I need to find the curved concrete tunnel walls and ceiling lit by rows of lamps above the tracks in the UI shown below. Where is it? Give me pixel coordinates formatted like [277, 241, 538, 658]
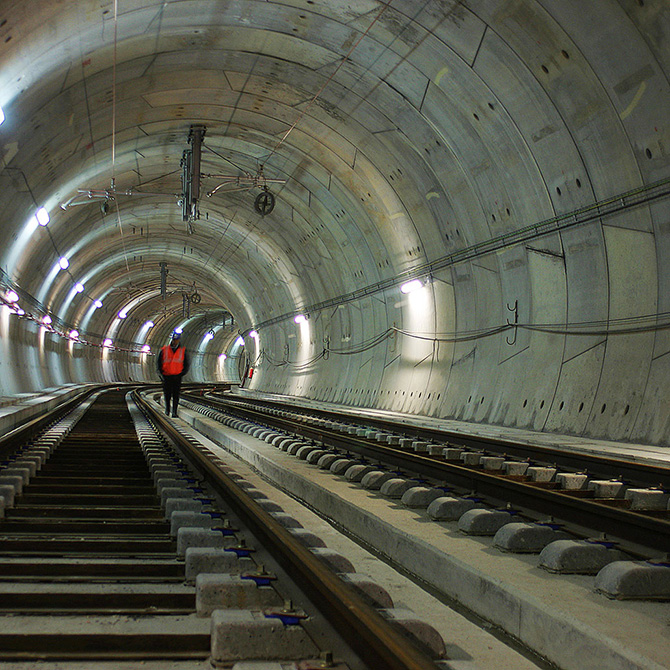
[0, 0, 670, 444]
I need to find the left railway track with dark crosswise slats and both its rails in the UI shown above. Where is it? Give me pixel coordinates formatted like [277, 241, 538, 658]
[0, 391, 452, 670]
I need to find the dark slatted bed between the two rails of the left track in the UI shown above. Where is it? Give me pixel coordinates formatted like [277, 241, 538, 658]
[0, 393, 209, 660]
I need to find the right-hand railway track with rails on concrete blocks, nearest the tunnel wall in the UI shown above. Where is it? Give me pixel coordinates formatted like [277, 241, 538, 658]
[182, 394, 670, 560]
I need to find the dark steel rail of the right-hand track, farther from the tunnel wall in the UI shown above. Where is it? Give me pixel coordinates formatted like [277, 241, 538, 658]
[188, 399, 670, 552]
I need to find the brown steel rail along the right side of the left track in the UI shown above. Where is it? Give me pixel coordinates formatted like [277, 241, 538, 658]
[134, 393, 444, 670]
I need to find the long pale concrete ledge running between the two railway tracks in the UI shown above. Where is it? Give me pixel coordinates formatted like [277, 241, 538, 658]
[181, 417, 670, 670]
